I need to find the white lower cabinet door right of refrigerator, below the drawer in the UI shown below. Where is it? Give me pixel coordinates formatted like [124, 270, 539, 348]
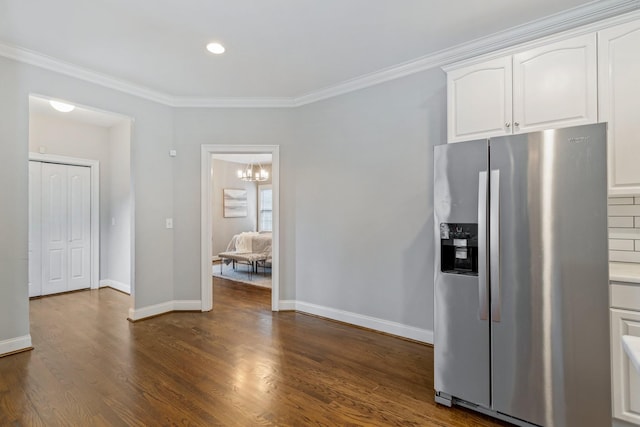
[611, 308, 640, 424]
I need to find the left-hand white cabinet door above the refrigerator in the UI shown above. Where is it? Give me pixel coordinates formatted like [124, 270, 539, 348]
[447, 57, 512, 142]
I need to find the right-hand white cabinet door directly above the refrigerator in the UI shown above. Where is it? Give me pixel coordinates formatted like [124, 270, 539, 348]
[513, 34, 598, 133]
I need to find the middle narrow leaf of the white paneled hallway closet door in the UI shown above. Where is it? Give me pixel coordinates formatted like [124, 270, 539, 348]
[42, 163, 69, 295]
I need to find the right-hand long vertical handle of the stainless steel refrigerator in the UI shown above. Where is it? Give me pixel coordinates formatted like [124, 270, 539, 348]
[489, 169, 502, 322]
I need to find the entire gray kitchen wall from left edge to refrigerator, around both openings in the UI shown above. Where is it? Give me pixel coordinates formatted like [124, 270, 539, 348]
[0, 53, 446, 348]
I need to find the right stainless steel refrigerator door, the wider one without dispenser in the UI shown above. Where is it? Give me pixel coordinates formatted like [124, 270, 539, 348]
[489, 124, 611, 426]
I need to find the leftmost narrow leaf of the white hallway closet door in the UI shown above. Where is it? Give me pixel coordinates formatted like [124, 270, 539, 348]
[29, 162, 42, 297]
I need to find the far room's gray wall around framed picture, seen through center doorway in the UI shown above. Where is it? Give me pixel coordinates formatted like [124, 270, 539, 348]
[211, 159, 258, 255]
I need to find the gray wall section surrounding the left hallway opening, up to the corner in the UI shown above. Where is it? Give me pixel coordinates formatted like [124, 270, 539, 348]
[0, 53, 174, 338]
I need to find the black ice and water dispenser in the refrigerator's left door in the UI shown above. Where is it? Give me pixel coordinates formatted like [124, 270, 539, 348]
[440, 223, 478, 276]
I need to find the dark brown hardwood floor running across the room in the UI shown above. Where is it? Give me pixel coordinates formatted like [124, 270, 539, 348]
[0, 279, 507, 426]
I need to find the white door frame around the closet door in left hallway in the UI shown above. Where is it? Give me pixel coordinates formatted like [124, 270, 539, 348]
[29, 152, 100, 289]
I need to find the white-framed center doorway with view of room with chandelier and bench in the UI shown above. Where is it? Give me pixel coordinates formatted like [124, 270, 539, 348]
[202, 145, 279, 311]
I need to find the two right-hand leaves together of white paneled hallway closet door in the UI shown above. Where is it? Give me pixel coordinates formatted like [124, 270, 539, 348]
[41, 163, 91, 295]
